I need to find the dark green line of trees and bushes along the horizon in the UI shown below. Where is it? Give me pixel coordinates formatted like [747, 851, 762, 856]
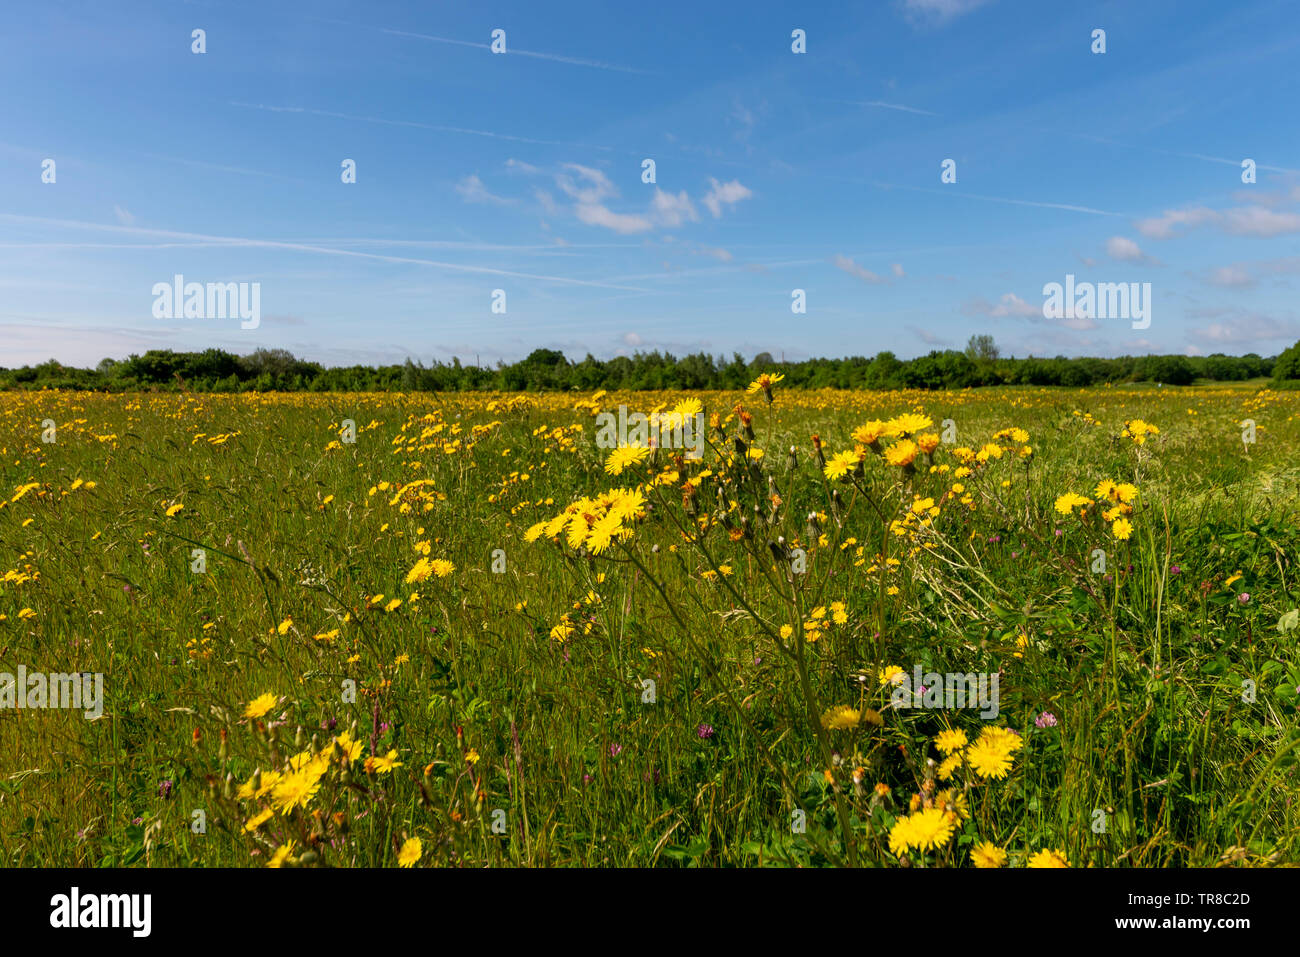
[0, 335, 1300, 393]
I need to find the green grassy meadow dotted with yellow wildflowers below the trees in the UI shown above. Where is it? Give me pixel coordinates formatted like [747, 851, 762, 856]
[0, 376, 1300, 867]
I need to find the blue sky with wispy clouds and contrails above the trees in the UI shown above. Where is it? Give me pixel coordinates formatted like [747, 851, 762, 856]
[0, 0, 1300, 367]
